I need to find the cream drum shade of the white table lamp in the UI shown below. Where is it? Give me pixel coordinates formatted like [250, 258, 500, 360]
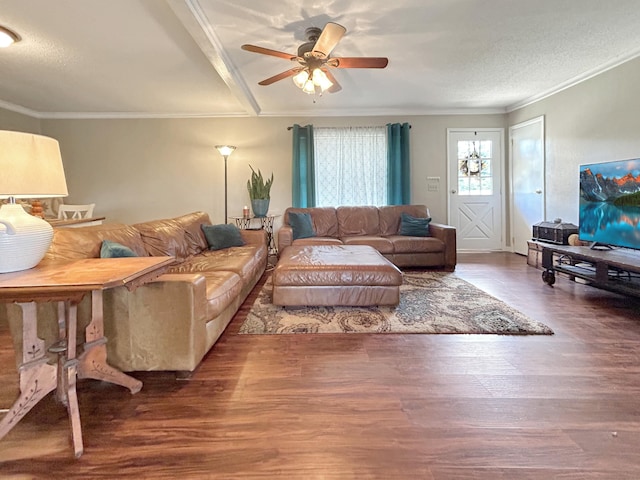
[0, 130, 68, 198]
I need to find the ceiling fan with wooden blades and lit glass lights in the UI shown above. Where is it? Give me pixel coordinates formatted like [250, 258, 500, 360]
[242, 22, 389, 94]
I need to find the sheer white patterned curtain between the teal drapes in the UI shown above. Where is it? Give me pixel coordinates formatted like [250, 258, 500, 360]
[314, 127, 387, 207]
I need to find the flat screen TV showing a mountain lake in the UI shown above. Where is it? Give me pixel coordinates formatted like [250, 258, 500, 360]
[579, 158, 640, 249]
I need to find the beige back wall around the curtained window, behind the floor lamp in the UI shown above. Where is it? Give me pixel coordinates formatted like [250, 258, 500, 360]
[42, 115, 505, 226]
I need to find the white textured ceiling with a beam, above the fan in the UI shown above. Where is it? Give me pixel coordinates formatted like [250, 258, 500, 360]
[0, 0, 640, 118]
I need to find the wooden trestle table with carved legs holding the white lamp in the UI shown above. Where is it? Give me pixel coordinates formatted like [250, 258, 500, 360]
[0, 257, 173, 457]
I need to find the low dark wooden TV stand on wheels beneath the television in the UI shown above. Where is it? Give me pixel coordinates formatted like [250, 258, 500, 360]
[542, 244, 640, 295]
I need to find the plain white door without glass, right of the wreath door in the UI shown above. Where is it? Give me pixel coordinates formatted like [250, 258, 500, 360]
[509, 117, 545, 255]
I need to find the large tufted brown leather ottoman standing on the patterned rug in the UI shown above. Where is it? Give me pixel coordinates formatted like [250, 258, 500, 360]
[272, 245, 402, 306]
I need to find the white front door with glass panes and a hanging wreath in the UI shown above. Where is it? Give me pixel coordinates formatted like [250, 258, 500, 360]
[447, 129, 504, 251]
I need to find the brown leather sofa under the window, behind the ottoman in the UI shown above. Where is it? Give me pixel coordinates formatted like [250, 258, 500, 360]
[278, 205, 456, 271]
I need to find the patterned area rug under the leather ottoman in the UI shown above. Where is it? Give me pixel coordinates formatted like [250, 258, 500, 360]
[239, 272, 553, 335]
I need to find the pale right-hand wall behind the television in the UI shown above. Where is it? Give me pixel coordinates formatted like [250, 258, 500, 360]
[508, 55, 640, 225]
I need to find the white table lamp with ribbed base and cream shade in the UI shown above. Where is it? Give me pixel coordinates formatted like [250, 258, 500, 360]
[0, 131, 68, 273]
